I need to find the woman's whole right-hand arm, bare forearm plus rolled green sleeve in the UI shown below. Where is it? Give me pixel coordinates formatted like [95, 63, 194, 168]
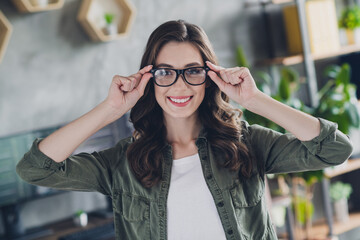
[207, 62, 352, 173]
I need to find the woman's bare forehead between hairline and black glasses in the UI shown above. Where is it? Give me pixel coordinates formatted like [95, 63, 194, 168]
[156, 41, 204, 67]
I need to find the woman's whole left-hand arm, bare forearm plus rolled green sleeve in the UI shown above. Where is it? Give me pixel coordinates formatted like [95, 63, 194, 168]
[16, 66, 151, 194]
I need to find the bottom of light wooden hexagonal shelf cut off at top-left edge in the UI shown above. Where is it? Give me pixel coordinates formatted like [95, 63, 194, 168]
[12, 0, 64, 13]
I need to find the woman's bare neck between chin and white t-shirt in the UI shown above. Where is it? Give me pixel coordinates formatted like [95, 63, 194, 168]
[164, 114, 201, 144]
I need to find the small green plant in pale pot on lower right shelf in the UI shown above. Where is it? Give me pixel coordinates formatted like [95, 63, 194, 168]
[330, 181, 352, 222]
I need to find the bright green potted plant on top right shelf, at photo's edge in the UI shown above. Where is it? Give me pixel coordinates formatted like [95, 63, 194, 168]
[338, 5, 360, 45]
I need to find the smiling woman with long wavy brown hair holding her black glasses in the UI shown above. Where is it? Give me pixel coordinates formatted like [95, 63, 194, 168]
[17, 21, 352, 239]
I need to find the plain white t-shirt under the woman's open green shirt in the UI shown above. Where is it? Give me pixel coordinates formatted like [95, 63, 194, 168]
[167, 154, 226, 240]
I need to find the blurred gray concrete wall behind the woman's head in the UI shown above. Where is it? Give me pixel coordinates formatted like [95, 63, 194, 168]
[0, 0, 270, 136]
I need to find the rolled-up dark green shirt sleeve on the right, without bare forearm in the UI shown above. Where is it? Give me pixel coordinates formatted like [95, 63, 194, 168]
[245, 118, 353, 173]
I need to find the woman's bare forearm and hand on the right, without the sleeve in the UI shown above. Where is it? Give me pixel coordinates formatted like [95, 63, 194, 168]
[207, 62, 320, 141]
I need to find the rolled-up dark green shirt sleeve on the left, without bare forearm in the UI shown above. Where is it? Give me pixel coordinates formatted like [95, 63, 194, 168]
[16, 139, 115, 195]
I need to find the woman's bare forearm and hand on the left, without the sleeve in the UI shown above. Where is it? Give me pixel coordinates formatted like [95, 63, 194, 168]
[39, 66, 152, 162]
